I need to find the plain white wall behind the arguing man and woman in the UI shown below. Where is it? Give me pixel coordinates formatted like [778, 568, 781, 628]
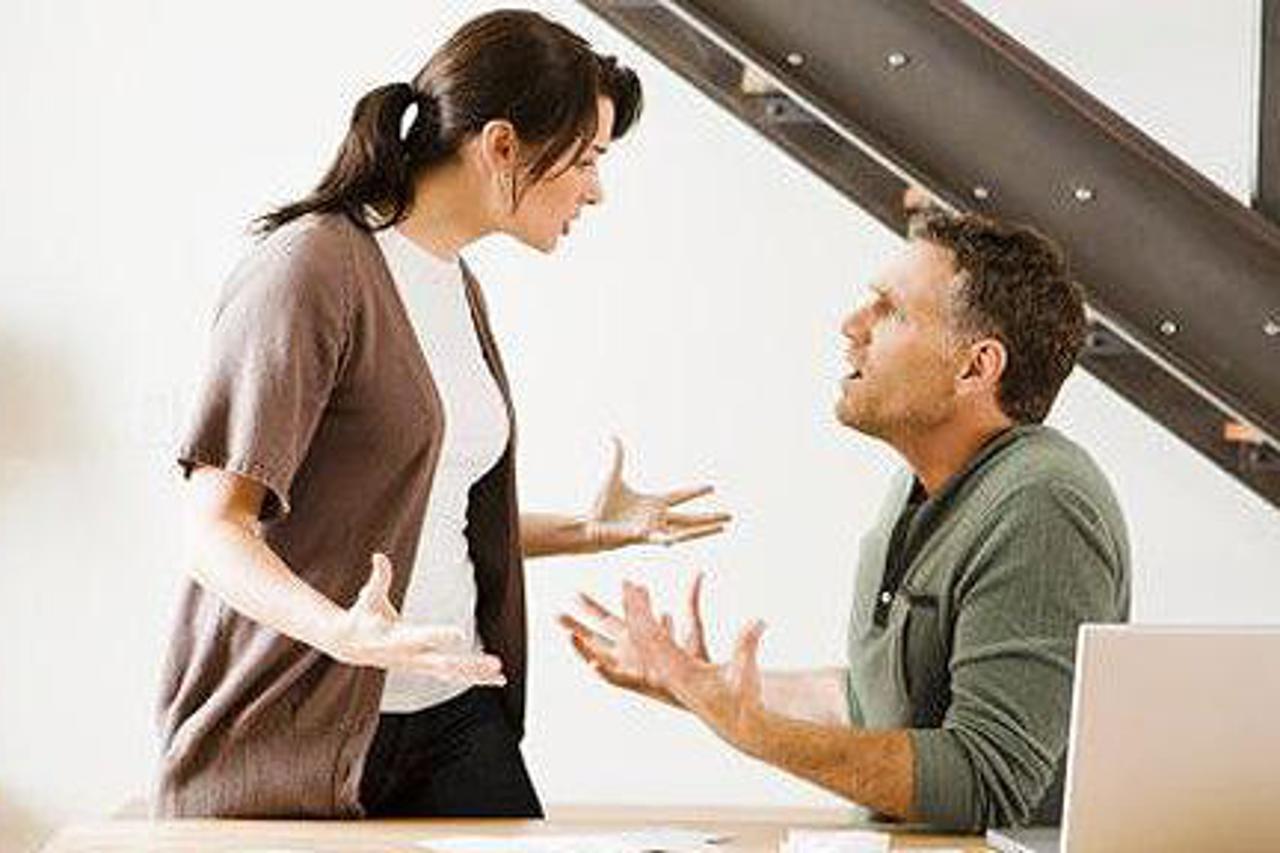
[0, 0, 1280, 850]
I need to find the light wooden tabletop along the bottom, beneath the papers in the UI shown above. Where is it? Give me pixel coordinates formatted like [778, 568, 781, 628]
[42, 806, 987, 853]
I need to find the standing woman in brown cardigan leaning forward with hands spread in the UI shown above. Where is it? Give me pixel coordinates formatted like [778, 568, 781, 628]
[156, 6, 727, 816]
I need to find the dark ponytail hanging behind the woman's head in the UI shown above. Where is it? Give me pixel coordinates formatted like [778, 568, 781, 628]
[255, 83, 439, 233]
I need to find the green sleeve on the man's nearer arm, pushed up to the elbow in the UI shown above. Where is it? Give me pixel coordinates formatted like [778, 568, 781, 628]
[911, 483, 1126, 829]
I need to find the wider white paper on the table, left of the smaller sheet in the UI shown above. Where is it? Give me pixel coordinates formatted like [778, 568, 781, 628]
[417, 829, 730, 853]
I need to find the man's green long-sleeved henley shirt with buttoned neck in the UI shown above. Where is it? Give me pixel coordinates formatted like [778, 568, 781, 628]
[849, 425, 1130, 830]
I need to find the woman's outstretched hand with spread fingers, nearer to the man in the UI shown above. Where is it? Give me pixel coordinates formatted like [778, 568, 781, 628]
[586, 438, 731, 549]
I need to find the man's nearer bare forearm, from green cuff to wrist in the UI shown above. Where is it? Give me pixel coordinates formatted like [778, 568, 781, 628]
[733, 710, 915, 818]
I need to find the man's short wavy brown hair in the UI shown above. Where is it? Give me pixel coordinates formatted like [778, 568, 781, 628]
[909, 207, 1085, 424]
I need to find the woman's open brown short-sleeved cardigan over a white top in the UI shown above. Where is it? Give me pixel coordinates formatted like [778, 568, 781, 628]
[154, 215, 525, 817]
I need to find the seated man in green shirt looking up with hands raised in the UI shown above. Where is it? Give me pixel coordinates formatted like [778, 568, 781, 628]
[561, 210, 1130, 829]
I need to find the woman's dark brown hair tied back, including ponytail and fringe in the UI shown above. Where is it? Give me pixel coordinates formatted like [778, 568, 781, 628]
[255, 10, 643, 232]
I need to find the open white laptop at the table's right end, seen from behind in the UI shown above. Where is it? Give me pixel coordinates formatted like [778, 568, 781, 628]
[987, 625, 1280, 853]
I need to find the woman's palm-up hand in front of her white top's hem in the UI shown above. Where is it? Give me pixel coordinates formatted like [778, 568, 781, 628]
[328, 553, 507, 686]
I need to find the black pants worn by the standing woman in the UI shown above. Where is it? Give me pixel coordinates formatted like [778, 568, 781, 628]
[360, 688, 543, 817]
